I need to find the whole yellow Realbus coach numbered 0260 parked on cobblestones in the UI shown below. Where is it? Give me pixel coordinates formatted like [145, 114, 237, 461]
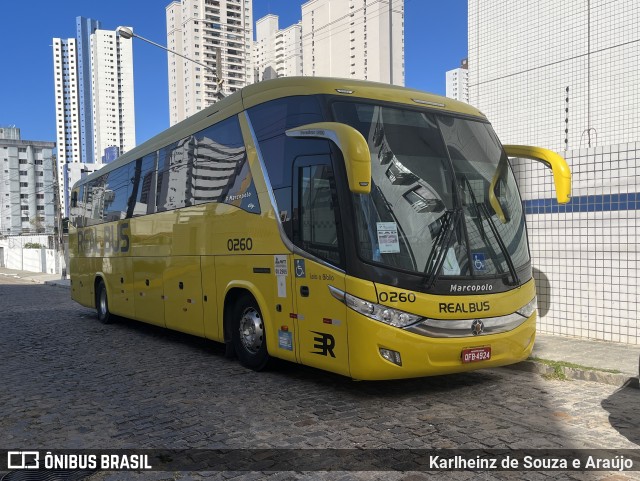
[70, 78, 570, 380]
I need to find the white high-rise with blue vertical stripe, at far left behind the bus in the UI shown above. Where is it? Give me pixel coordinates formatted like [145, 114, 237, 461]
[53, 17, 136, 216]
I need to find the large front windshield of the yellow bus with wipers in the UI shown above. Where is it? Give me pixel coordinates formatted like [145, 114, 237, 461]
[332, 101, 529, 284]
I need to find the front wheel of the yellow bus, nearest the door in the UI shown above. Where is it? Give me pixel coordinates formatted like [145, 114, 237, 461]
[232, 294, 269, 371]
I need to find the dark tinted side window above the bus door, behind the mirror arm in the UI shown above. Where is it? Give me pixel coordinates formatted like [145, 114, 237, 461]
[249, 95, 330, 188]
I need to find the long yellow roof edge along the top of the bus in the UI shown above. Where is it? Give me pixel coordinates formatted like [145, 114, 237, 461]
[78, 77, 486, 184]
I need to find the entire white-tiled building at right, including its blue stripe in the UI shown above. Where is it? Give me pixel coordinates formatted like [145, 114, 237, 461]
[468, 0, 640, 344]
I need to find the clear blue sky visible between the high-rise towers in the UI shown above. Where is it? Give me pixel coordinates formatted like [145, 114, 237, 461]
[0, 0, 467, 144]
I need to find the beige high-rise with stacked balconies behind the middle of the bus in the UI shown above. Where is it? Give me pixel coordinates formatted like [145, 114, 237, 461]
[166, 0, 253, 125]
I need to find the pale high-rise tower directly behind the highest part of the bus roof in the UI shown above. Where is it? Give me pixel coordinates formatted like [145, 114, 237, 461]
[302, 0, 404, 85]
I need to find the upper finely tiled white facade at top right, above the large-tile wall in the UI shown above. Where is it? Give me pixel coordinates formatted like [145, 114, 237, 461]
[468, 0, 640, 151]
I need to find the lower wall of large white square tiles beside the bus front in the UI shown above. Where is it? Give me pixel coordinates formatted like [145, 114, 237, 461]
[512, 142, 640, 344]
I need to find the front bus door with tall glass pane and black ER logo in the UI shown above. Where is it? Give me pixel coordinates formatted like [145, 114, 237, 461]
[292, 155, 349, 376]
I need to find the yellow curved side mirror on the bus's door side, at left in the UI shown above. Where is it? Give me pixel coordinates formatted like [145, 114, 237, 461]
[286, 122, 371, 194]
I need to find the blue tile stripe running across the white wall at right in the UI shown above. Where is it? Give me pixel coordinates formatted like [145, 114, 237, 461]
[523, 192, 640, 215]
